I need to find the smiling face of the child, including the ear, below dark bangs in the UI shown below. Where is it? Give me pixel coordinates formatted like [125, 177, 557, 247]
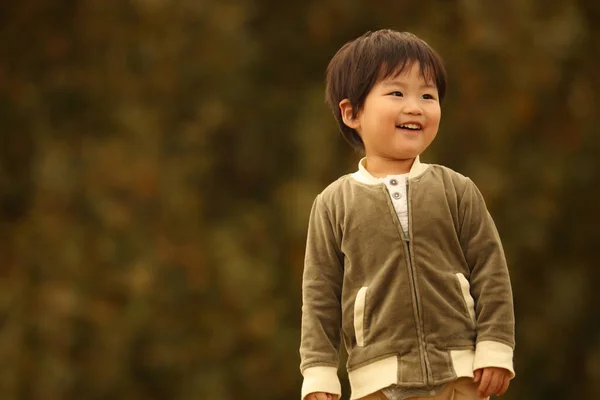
[340, 62, 441, 160]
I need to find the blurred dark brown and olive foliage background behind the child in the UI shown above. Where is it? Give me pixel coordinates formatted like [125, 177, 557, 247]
[0, 0, 600, 400]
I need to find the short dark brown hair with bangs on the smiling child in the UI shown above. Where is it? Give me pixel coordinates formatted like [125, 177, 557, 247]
[325, 29, 446, 151]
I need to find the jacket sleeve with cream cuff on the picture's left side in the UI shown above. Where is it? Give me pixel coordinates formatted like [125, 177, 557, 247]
[300, 195, 344, 399]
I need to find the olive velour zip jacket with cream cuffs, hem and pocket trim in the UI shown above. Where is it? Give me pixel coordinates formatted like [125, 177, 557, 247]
[300, 158, 514, 399]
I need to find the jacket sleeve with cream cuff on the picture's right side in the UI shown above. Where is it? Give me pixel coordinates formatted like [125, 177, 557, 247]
[459, 179, 515, 378]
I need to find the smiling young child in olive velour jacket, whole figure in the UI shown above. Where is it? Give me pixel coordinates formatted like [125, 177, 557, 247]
[300, 30, 514, 400]
